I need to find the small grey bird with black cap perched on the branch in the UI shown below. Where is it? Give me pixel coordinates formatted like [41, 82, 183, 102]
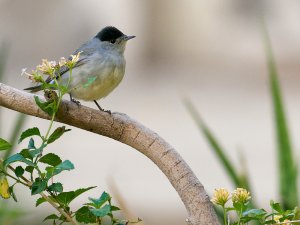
[24, 26, 136, 113]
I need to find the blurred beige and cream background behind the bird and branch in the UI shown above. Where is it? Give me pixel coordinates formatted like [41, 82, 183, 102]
[0, 0, 300, 225]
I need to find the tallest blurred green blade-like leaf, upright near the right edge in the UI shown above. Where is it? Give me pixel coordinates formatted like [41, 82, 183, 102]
[264, 28, 299, 208]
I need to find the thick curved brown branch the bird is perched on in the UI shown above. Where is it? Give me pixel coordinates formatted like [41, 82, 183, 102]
[0, 83, 219, 225]
